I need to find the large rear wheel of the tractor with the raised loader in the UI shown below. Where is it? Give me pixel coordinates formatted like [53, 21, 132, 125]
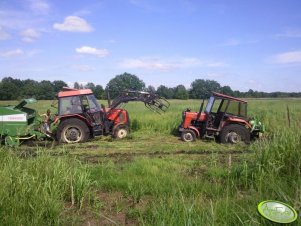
[57, 118, 90, 144]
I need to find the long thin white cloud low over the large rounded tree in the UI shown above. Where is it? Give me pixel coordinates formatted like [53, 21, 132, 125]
[120, 57, 226, 71]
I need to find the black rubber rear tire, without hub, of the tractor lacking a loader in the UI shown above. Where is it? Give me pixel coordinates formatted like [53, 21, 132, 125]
[220, 124, 251, 144]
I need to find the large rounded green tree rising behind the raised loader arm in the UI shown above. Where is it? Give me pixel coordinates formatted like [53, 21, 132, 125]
[106, 73, 145, 98]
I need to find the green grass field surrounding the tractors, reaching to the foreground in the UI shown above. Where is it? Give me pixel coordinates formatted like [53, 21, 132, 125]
[0, 99, 301, 225]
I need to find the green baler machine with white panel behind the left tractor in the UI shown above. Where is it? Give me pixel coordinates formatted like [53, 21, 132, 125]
[0, 98, 48, 146]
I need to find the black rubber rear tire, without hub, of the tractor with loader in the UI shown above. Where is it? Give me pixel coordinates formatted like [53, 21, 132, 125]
[56, 118, 90, 144]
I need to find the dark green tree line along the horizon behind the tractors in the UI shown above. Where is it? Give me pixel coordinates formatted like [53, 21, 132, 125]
[0, 73, 301, 100]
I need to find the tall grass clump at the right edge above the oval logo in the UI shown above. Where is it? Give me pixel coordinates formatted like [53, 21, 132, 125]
[255, 127, 301, 209]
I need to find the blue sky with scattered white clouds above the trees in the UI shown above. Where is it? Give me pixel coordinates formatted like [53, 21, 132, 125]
[0, 0, 301, 92]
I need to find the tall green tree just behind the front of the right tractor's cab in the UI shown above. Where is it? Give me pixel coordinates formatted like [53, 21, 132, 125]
[190, 79, 221, 99]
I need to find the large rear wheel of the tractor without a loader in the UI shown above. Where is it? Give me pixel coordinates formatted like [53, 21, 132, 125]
[220, 124, 250, 144]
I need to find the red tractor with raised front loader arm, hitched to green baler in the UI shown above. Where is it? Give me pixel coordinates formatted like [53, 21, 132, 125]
[52, 88, 169, 143]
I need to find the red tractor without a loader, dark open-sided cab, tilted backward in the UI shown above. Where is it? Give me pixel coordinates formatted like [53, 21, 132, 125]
[179, 92, 264, 144]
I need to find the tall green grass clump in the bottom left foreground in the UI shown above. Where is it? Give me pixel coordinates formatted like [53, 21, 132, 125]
[0, 149, 91, 225]
